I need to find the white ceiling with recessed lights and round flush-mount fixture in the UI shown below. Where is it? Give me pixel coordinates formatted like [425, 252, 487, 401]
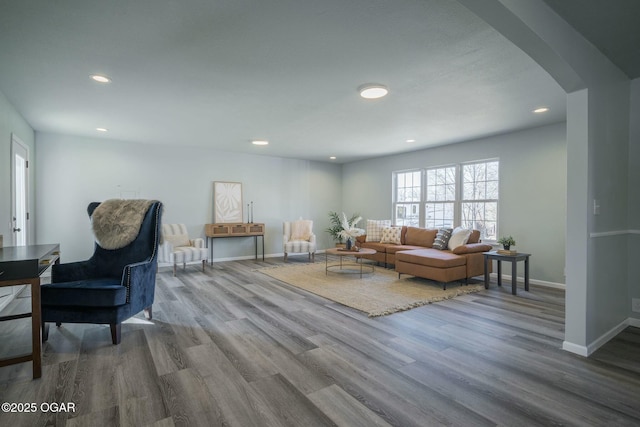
[0, 0, 640, 162]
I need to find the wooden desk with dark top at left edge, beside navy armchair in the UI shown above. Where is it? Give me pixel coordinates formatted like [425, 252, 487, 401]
[0, 244, 60, 378]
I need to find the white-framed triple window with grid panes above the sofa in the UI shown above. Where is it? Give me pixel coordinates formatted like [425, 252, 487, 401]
[393, 160, 500, 241]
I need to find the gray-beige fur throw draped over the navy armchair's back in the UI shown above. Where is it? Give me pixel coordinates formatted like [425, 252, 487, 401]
[91, 199, 155, 250]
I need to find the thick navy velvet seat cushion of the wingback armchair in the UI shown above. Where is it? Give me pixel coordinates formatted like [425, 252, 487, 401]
[40, 278, 127, 307]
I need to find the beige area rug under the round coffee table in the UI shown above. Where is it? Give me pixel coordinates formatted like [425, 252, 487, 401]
[258, 262, 484, 317]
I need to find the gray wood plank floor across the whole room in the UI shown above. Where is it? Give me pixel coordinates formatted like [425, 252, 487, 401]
[0, 257, 640, 427]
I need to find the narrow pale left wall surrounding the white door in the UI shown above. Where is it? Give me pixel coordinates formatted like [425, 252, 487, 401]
[0, 88, 35, 246]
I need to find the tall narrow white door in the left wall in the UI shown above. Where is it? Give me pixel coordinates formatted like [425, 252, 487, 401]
[11, 135, 29, 246]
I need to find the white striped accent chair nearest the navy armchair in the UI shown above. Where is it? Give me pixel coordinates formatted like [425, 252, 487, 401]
[158, 224, 207, 276]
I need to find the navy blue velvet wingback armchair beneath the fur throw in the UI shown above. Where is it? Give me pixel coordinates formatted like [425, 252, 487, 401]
[41, 200, 162, 344]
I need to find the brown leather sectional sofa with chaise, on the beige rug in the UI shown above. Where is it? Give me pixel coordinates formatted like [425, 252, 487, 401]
[357, 226, 492, 289]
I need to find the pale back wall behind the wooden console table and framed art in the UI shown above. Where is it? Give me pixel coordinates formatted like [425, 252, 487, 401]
[36, 133, 342, 262]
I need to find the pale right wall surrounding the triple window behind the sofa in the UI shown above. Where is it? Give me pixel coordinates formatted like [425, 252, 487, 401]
[343, 124, 567, 283]
